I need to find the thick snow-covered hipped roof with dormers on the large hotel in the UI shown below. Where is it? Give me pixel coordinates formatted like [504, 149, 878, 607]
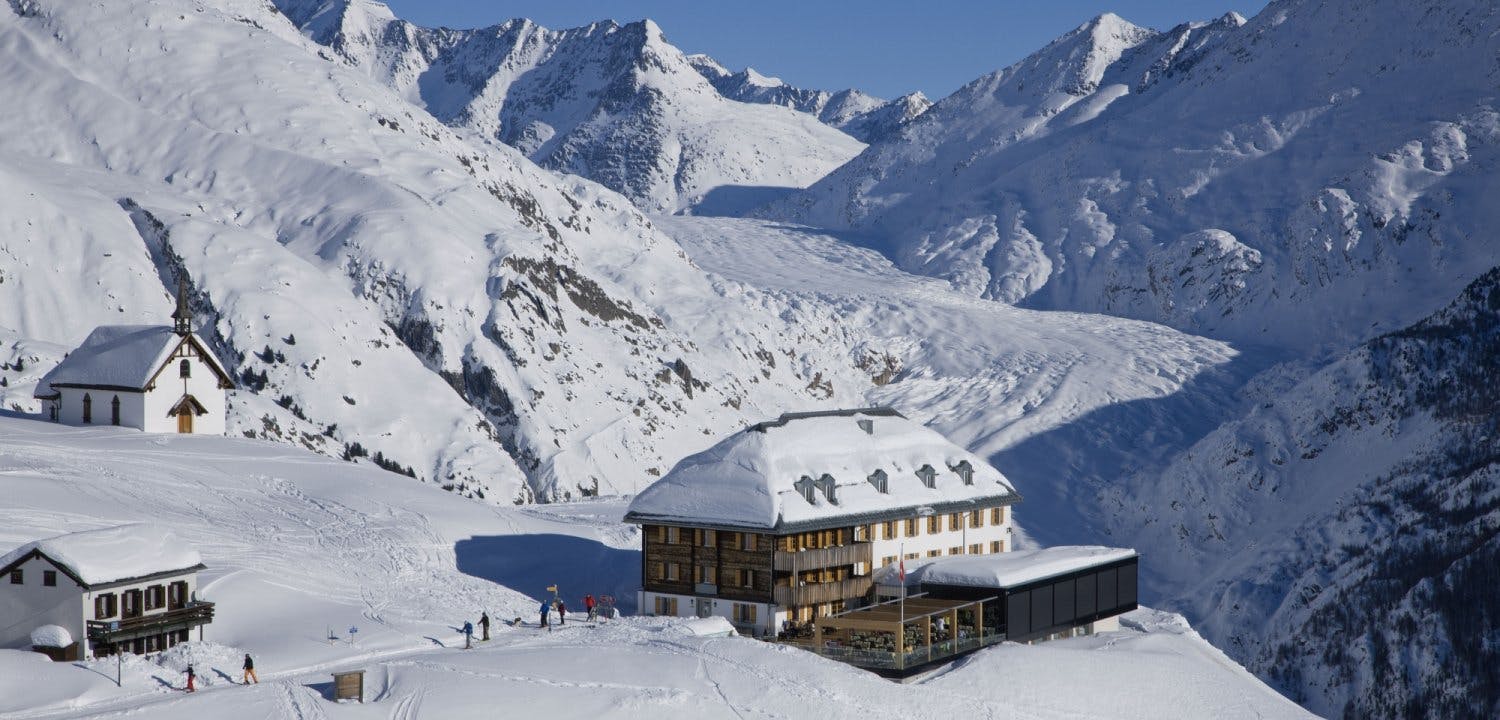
[626, 408, 1020, 531]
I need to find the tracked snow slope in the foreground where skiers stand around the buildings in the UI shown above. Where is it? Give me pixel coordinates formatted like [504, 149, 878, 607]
[0, 417, 1308, 720]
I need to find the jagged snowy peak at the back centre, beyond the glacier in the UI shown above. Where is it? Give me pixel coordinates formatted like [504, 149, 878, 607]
[276, 0, 863, 212]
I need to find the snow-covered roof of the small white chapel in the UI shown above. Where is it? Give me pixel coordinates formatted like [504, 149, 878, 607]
[36, 326, 228, 398]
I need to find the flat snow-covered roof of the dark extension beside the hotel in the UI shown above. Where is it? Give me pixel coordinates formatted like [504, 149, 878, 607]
[876, 545, 1136, 588]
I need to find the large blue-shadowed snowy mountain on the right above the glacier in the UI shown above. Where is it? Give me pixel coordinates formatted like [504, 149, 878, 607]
[768, 0, 1500, 351]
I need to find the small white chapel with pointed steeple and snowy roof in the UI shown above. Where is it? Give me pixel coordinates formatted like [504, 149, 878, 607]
[36, 279, 234, 435]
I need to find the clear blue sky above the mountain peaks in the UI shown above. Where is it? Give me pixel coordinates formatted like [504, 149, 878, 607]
[386, 0, 1266, 99]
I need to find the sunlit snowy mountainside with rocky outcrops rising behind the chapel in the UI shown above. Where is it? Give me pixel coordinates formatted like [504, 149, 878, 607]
[0, 0, 870, 503]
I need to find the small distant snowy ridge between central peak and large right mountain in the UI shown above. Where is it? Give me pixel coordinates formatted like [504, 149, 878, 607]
[687, 54, 932, 143]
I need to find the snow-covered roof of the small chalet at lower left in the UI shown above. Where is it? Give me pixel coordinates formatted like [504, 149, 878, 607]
[0, 524, 203, 587]
